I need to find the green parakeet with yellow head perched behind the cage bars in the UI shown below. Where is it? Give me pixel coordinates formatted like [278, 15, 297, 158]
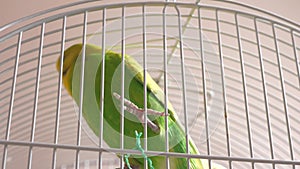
[56, 44, 223, 169]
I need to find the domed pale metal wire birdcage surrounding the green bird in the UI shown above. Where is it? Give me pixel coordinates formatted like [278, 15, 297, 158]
[0, 1, 300, 169]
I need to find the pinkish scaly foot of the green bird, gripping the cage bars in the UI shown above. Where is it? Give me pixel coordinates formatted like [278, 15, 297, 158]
[113, 92, 169, 133]
